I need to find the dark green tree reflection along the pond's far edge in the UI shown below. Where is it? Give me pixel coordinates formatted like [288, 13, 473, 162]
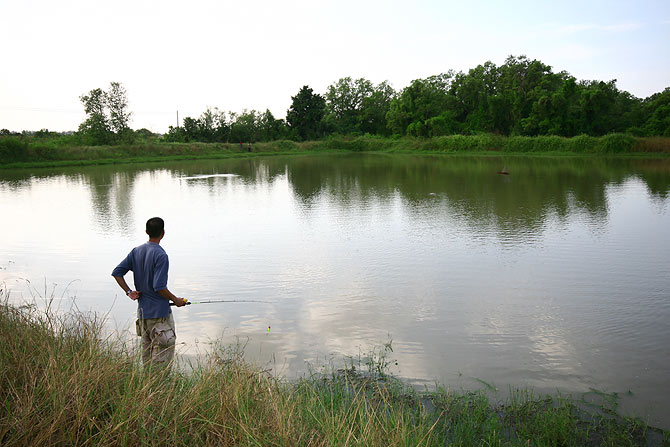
[0, 154, 670, 241]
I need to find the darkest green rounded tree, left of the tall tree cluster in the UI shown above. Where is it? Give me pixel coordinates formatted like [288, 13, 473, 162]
[286, 85, 326, 140]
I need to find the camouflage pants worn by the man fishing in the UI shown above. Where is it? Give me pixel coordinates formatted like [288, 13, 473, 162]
[136, 314, 177, 367]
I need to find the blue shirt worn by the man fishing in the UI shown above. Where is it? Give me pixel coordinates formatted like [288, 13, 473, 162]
[112, 242, 172, 318]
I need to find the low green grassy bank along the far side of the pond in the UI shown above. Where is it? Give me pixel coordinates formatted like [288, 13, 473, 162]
[0, 134, 670, 168]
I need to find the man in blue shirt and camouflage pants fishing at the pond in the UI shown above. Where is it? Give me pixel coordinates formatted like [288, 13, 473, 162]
[112, 217, 186, 367]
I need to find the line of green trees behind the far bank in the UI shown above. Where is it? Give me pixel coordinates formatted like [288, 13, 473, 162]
[3, 56, 670, 144]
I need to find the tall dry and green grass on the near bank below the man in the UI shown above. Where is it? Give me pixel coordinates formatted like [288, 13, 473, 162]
[0, 291, 670, 446]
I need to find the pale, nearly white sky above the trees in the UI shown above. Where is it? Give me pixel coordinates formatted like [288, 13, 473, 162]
[0, 0, 670, 133]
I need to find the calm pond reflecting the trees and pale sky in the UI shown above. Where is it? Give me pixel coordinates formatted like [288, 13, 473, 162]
[0, 153, 670, 429]
